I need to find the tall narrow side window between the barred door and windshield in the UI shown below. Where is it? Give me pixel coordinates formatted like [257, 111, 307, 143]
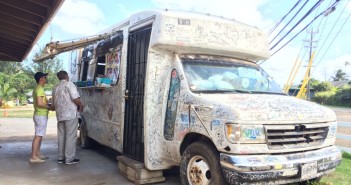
[164, 69, 180, 140]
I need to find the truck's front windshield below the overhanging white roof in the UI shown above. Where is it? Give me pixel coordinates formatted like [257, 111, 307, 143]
[181, 58, 284, 94]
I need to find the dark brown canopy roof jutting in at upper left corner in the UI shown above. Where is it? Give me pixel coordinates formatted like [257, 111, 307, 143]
[0, 0, 64, 62]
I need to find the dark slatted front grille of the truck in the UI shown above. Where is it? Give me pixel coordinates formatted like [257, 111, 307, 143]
[265, 124, 328, 149]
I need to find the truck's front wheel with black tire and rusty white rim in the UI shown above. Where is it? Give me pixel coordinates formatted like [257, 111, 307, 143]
[180, 142, 226, 185]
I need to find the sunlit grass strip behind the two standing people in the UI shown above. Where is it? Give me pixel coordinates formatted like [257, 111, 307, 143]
[0, 106, 56, 118]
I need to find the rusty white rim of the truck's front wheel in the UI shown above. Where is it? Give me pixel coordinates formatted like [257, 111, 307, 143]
[187, 155, 211, 185]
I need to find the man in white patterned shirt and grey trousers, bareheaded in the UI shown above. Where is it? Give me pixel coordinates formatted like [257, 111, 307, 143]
[52, 71, 83, 164]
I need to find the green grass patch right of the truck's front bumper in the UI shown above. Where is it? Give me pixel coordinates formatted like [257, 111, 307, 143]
[318, 152, 351, 185]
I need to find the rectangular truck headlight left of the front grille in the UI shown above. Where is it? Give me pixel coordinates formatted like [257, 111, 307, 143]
[225, 123, 266, 143]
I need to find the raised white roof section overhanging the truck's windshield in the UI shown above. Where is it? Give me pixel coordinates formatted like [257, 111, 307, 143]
[108, 10, 270, 61]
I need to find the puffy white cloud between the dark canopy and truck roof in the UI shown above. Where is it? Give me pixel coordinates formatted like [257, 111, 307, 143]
[52, 0, 106, 36]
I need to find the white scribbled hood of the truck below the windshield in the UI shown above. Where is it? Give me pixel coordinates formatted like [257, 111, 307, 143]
[201, 94, 336, 123]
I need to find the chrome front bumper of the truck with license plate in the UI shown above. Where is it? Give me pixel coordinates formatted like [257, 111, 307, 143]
[220, 146, 342, 184]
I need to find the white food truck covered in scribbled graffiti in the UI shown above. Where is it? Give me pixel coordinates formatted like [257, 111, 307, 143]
[37, 10, 341, 185]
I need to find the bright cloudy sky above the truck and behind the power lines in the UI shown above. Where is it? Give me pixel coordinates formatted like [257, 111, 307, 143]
[45, 0, 351, 86]
